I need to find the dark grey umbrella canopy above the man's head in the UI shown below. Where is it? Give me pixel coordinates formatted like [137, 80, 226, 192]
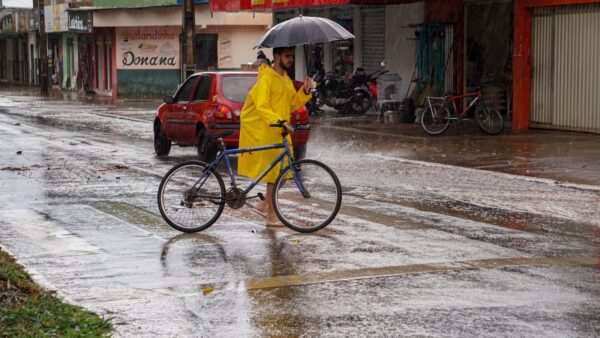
[254, 15, 354, 48]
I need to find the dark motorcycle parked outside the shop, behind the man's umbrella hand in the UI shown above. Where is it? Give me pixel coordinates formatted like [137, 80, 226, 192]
[307, 62, 388, 115]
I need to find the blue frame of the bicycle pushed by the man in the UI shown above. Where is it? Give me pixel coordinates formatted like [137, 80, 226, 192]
[194, 138, 309, 197]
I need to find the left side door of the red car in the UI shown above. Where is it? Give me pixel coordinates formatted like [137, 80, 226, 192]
[166, 76, 198, 143]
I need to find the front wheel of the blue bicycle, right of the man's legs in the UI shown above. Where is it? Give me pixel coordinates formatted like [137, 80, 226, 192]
[273, 160, 342, 232]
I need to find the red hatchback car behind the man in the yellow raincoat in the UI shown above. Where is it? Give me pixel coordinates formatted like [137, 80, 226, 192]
[154, 71, 309, 161]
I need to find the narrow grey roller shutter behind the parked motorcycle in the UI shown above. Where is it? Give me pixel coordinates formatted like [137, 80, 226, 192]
[361, 6, 385, 73]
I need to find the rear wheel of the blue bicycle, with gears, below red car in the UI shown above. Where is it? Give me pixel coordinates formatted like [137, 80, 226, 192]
[158, 161, 225, 232]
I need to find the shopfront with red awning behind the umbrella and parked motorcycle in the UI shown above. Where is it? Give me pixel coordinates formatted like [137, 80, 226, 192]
[211, 0, 464, 105]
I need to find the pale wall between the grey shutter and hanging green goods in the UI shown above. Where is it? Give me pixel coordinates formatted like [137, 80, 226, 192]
[385, 2, 425, 99]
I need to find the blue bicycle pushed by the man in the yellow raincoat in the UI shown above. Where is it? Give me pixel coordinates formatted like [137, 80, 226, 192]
[158, 121, 342, 232]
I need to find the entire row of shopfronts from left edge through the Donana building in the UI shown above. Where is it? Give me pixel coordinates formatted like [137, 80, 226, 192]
[0, 0, 272, 97]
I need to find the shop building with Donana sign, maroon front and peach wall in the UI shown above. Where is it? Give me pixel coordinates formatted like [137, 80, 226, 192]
[93, 0, 271, 96]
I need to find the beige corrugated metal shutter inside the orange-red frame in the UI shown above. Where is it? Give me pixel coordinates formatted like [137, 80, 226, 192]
[530, 4, 600, 133]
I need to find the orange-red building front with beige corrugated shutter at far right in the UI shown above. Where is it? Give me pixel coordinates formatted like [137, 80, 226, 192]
[513, 0, 600, 133]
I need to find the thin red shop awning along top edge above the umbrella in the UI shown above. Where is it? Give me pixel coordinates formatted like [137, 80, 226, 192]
[210, 0, 412, 12]
